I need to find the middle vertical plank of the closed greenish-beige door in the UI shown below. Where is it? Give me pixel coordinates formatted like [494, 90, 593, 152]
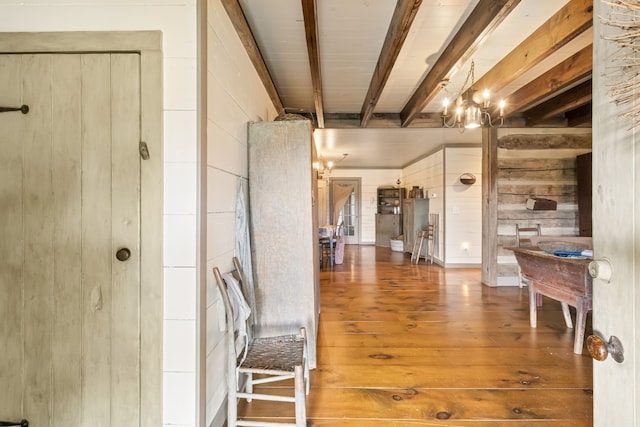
[51, 55, 82, 425]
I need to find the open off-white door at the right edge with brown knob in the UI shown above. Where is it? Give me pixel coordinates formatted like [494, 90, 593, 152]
[592, 1, 640, 427]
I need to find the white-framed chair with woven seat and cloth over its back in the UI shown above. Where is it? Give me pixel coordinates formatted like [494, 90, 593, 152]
[213, 257, 309, 427]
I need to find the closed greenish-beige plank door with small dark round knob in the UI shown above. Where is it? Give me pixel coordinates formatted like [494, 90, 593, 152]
[0, 53, 141, 427]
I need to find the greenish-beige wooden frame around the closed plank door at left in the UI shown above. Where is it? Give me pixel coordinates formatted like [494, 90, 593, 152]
[0, 31, 164, 427]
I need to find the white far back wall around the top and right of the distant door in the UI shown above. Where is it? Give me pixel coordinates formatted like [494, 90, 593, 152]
[331, 169, 402, 245]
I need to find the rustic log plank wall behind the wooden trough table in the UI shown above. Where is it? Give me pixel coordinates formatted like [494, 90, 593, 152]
[496, 133, 591, 286]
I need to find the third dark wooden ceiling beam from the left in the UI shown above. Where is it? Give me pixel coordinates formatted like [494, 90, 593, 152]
[360, 0, 422, 127]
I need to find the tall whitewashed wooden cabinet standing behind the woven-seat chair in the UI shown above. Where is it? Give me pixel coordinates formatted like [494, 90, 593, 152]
[249, 120, 320, 367]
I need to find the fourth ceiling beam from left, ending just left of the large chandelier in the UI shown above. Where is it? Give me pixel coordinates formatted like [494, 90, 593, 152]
[400, 0, 520, 127]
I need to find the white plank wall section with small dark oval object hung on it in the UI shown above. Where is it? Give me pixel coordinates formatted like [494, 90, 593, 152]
[444, 146, 482, 266]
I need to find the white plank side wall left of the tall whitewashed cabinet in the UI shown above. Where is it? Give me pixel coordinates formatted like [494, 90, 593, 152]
[206, 0, 276, 426]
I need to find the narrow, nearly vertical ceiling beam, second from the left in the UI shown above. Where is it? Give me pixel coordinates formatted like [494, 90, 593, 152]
[302, 0, 324, 128]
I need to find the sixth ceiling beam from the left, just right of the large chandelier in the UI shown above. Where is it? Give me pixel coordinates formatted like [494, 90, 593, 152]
[504, 45, 593, 116]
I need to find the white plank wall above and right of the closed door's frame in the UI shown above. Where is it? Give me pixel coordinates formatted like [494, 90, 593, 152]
[0, 0, 197, 427]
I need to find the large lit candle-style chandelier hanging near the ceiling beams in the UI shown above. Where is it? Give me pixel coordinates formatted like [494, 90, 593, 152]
[441, 60, 506, 132]
